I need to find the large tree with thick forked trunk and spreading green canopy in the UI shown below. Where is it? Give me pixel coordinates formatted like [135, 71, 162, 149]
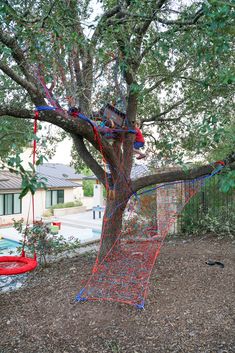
[0, 0, 235, 256]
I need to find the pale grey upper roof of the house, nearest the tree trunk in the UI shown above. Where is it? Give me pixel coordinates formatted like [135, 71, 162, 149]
[37, 163, 84, 180]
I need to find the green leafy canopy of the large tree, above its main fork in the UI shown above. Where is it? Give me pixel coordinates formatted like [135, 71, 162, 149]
[1, 0, 235, 190]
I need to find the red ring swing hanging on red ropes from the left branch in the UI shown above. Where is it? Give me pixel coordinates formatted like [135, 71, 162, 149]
[0, 111, 39, 276]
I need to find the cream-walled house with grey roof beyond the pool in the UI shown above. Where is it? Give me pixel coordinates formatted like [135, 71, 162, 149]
[0, 166, 83, 226]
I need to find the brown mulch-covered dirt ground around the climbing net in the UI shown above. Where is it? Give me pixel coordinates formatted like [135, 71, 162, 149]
[0, 236, 235, 353]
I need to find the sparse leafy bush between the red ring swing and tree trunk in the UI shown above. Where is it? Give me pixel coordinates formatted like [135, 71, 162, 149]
[14, 219, 81, 265]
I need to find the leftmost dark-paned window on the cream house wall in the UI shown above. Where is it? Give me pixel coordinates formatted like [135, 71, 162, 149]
[0, 194, 22, 216]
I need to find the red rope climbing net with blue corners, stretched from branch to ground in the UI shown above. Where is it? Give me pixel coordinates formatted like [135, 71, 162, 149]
[77, 180, 202, 308]
